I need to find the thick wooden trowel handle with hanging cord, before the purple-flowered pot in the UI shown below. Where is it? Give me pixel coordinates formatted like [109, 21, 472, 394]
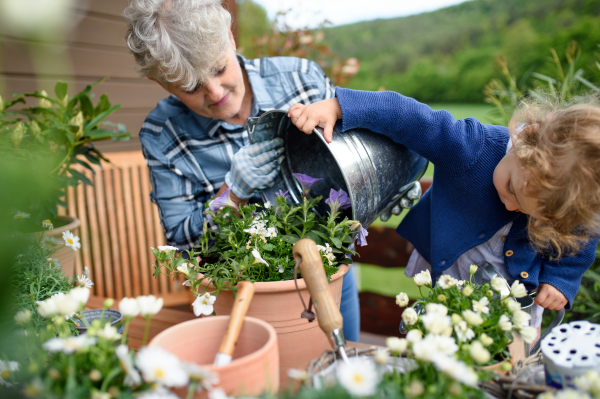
[293, 238, 344, 335]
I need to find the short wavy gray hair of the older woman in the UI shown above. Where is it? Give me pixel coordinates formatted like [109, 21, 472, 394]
[123, 0, 231, 91]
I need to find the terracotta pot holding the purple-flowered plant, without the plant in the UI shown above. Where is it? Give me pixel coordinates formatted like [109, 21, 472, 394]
[203, 265, 350, 388]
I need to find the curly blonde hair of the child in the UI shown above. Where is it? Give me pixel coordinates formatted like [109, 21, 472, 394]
[509, 98, 600, 259]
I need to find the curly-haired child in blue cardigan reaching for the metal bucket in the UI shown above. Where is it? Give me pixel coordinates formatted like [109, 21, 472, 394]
[288, 88, 600, 328]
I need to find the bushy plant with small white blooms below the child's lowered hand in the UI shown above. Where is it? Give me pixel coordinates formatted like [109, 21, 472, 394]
[396, 265, 537, 365]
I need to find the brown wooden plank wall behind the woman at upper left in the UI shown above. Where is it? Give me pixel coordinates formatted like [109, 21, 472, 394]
[0, 0, 235, 152]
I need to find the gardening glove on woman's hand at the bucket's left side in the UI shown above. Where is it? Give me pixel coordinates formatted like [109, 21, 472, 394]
[225, 138, 284, 199]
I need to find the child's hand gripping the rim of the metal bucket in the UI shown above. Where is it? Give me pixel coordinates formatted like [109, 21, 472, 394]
[288, 98, 342, 143]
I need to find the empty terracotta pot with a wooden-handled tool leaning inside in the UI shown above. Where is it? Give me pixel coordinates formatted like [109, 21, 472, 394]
[148, 316, 279, 399]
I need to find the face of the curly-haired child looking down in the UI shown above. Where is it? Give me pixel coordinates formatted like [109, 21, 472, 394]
[494, 151, 537, 215]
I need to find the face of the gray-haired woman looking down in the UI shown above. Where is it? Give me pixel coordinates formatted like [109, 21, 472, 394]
[167, 32, 246, 121]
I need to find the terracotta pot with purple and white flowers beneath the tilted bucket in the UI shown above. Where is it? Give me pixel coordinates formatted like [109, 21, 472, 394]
[153, 173, 366, 386]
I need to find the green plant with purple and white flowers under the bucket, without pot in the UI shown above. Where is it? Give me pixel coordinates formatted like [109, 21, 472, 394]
[153, 173, 367, 315]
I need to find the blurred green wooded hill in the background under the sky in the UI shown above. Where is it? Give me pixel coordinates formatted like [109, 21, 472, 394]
[325, 0, 600, 102]
